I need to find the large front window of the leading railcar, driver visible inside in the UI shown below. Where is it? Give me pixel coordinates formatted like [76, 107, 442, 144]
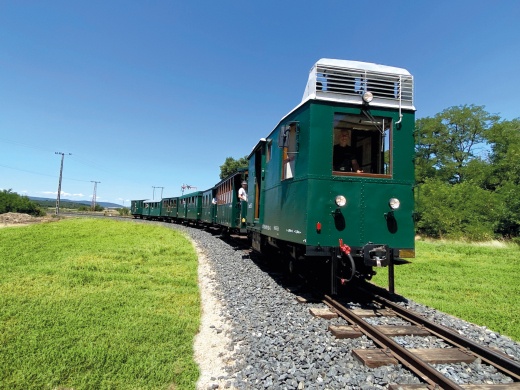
[332, 114, 392, 176]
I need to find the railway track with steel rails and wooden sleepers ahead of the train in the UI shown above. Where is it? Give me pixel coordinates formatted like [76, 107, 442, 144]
[304, 289, 520, 390]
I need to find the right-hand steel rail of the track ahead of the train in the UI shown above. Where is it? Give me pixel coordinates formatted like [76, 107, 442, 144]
[364, 290, 520, 382]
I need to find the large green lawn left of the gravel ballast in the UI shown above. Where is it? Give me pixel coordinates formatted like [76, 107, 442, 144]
[0, 219, 200, 390]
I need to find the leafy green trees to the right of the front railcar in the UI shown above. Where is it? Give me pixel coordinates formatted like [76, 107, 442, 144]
[415, 105, 520, 242]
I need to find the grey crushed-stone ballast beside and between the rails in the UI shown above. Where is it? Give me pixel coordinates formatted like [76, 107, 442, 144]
[160, 224, 520, 389]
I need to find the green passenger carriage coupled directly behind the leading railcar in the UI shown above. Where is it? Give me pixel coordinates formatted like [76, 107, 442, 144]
[215, 169, 248, 233]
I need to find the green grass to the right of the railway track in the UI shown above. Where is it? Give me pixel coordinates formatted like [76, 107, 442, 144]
[373, 241, 520, 341]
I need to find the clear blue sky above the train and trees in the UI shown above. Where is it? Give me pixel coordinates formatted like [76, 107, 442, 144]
[0, 0, 520, 206]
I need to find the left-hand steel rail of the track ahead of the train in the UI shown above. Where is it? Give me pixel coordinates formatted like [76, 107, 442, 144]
[323, 295, 462, 390]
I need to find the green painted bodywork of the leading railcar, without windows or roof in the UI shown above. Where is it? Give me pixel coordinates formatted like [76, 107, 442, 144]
[248, 102, 415, 248]
